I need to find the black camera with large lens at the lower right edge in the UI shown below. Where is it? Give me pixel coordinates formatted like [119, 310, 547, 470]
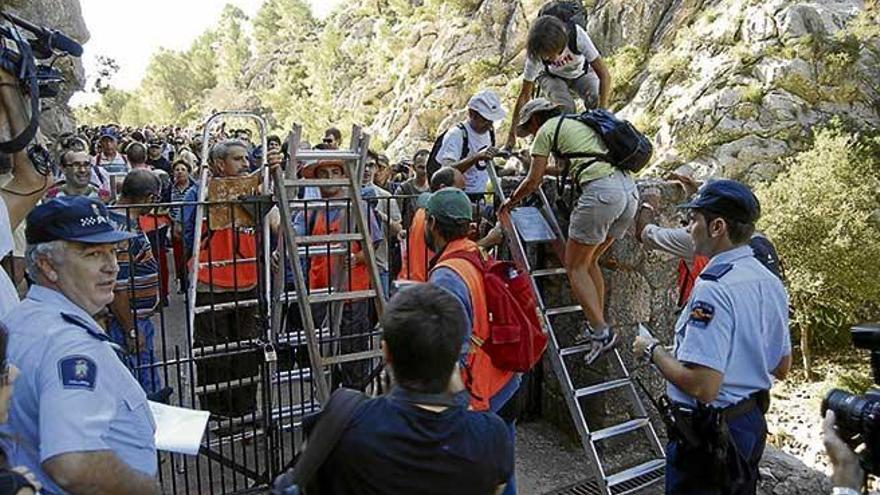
[822, 323, 880, 475]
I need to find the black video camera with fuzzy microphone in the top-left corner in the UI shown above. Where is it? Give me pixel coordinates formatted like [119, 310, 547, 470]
[0, 12, 83, 170]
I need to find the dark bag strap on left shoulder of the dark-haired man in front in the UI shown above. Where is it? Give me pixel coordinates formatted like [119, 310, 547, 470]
[273, 388, 369, 493]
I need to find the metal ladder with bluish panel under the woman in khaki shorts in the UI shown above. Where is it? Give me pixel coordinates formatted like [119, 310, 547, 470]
[488, 167, 665, 495]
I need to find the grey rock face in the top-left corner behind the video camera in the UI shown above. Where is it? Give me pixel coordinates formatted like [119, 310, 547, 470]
[0, 0, 89, 140]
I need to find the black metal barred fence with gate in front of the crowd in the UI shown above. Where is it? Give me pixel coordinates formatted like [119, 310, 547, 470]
[104, 189, 493, 494]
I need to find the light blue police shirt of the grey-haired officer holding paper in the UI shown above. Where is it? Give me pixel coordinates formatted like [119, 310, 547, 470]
[2, 285, 157, 494]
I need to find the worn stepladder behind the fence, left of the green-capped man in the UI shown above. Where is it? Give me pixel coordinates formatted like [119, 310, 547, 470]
[273, 125, 385, 403]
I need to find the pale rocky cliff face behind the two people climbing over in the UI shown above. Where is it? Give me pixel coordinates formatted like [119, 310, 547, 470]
[320, 0, 880, 181]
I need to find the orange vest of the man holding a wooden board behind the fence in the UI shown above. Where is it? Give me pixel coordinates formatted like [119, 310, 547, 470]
[199, 227, 257, 290]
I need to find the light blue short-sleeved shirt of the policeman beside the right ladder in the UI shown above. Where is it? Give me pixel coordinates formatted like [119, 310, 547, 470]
[667, 245, 791, 407]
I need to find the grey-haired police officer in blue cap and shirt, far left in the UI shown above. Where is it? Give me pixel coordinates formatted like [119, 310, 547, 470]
[3, 196, 159, 494]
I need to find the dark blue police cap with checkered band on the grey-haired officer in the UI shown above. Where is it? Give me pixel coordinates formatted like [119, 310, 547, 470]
[25, 196, 137, 244]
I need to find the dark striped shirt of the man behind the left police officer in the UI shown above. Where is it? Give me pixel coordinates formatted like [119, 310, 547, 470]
[110, 211, 159, 318]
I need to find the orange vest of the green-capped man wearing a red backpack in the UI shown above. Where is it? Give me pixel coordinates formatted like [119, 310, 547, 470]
[432, 239, 514, 411]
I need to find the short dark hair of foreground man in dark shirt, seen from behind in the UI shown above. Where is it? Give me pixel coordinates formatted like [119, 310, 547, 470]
[381, 284, 467, 394]
